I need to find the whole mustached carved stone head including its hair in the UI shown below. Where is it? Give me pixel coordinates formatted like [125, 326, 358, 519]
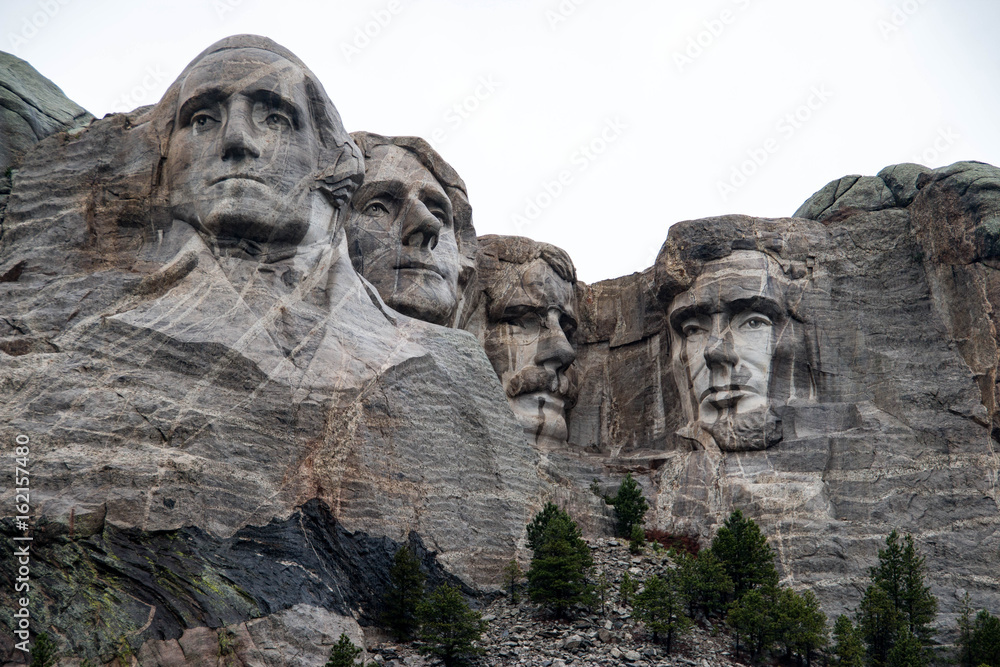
[470, 236, 577, 445]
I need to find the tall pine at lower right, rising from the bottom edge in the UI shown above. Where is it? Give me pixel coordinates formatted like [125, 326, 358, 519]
[857, 531, 937, 667]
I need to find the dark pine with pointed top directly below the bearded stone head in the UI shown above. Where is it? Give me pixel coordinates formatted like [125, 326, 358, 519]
[711, 510, 778, 600]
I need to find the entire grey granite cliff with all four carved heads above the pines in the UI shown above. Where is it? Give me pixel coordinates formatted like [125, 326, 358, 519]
[0, 36, 1000, 665]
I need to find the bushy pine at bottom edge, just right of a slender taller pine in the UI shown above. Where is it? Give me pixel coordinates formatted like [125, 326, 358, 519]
[417, 584, 486, 667]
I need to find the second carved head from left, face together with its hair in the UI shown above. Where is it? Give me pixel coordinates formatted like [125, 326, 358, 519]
[346, 132, 476, 326]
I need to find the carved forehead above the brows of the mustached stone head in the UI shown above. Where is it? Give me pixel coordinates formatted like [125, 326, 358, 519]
[490, 259, 576, 320]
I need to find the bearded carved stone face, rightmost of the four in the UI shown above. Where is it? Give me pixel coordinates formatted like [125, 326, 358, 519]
[667, 250, 815, 451]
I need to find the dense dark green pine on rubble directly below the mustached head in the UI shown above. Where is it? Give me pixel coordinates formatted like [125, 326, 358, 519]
[528, 503, 594, 616]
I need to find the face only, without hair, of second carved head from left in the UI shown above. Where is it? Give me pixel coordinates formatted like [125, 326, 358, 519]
[347, 145, 460, 325]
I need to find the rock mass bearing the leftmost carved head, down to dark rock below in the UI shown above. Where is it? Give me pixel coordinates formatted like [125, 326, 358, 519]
[0, 37, 543, 664]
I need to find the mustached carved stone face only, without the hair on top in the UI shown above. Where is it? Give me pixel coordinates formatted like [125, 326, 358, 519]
[484, 259, 576, 444]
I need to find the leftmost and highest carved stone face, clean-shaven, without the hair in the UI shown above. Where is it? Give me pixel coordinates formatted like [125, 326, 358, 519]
[165, 48, 329, 246]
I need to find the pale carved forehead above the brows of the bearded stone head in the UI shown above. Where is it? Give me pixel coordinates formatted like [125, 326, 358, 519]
[668, 250, 788, 314]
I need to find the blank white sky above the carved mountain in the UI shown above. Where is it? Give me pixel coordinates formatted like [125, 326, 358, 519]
[0, 0, 1000, 282]
